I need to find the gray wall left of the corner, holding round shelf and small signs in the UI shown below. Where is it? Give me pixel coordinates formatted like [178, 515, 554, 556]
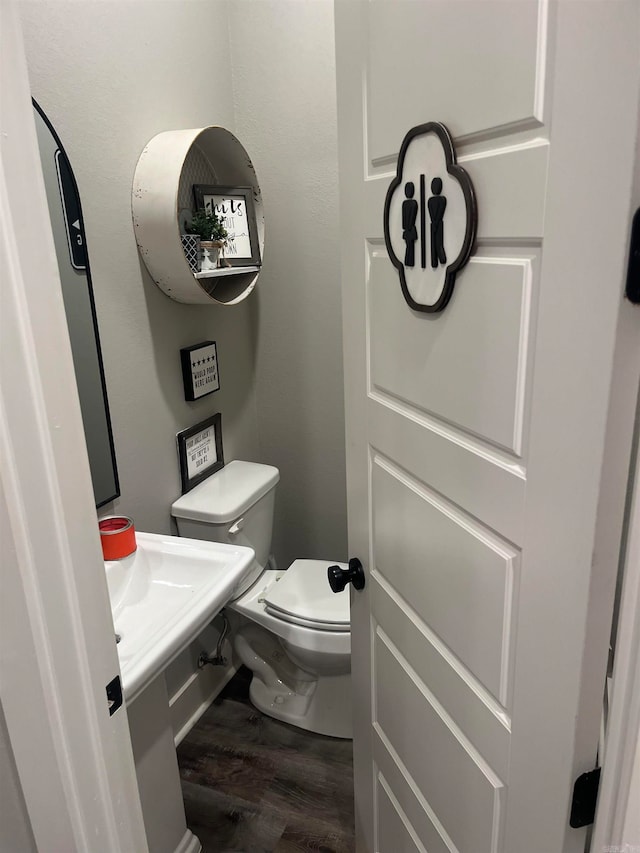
[21, 0, 257, 532]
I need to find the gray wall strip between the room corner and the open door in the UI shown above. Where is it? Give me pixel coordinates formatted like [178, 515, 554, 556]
[229, 0, 347, 566]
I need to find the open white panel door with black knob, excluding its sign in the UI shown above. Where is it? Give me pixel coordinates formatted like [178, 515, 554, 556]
[336, 0, 640, 853]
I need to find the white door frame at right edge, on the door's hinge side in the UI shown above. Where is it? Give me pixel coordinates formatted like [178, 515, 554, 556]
[590, 90, 640, 853]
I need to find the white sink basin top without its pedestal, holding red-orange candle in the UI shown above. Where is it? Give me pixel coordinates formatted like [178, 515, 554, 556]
[105, 533, 255, 702]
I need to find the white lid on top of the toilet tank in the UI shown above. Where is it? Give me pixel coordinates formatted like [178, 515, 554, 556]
[171, 459, 280, 524]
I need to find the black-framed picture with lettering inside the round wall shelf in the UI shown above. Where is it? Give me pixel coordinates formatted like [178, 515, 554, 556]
[193, 184, 260, 267]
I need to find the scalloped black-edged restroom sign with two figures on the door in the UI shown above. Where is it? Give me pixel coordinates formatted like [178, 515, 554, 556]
[384, 122, 478, 312]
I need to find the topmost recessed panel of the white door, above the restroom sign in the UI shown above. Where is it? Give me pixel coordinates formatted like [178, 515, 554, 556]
[362, 0, 549, 159]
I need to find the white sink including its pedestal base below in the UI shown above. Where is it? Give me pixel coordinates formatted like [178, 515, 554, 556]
[105, 533, 255, 853]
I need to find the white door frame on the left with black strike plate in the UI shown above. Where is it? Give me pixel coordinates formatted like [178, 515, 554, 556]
[0, 2, 147, 853]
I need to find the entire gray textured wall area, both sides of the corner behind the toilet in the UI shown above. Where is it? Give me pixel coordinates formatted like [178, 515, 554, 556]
[21, 0, 346, 565]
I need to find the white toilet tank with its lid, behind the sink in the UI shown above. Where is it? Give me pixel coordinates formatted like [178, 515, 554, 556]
[171, 460, 280, 597]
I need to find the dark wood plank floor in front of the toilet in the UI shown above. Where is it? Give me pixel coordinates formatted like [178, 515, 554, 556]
[178, 667, 355, 853]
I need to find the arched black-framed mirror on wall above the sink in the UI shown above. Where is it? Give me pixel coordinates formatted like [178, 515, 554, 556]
[32, 100, 120, 507]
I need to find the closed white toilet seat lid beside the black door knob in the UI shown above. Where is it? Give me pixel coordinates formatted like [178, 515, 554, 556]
[263, 560, 351, 632]
